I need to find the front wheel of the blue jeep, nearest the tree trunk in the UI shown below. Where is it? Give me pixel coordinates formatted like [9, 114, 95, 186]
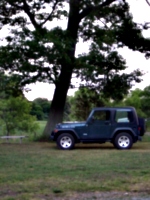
[57, 133, 75, 150]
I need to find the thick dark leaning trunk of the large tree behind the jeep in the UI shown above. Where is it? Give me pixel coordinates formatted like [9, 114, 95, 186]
[44, 0, 79, 137]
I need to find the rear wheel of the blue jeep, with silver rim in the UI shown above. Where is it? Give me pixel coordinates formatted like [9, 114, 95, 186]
[114, 132, 133, 149]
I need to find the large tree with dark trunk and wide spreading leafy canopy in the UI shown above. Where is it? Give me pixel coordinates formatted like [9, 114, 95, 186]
[0, 0, 150, 135]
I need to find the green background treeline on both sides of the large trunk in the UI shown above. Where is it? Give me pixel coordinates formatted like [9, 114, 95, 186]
[0, 73, 150, 138]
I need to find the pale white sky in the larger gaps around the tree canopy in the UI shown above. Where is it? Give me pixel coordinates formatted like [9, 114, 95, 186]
[1, 0, 150, 101]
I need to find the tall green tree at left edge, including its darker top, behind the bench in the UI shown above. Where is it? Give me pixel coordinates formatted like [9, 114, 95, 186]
[0, 73, 38, 135]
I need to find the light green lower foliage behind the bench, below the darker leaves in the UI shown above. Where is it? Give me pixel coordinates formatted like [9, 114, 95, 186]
[0, 97, 38, 135]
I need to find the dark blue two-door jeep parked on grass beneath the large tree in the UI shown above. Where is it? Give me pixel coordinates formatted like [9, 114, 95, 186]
[51, 107, 145, 150]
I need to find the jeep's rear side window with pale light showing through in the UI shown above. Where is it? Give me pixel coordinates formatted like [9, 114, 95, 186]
[115, 110, 133, 123]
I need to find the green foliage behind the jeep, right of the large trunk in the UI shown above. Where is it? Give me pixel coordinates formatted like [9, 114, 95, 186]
[64, 86, 150, 121]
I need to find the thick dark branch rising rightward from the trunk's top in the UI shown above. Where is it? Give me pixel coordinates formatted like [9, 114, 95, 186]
[79, 0, 116, 21]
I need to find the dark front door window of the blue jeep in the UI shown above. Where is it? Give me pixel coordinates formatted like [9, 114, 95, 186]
[93, 110, 110, 121]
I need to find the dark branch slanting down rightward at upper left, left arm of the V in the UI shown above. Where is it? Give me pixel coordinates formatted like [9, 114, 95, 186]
[23, 0, 40, 29]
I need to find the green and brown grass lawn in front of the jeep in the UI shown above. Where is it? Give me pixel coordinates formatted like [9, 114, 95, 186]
[0, 138, 150, 200]
